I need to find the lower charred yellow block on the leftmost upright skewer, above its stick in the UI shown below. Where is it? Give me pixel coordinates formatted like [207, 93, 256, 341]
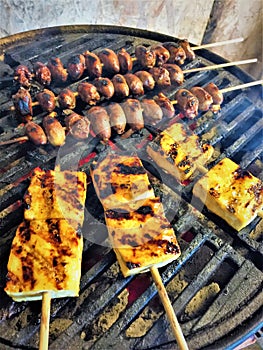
[5, 219, 83, 301]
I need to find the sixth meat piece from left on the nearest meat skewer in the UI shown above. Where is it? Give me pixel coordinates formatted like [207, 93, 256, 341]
[122, 98, 144, 131]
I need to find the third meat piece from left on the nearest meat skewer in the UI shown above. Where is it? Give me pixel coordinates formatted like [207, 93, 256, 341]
[65, 112, 90, 140]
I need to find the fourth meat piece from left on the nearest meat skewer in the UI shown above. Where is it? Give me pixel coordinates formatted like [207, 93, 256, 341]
[87, 106, 111, 142]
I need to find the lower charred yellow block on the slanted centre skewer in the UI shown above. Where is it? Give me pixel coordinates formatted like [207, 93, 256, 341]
[105, 197, 180, 277]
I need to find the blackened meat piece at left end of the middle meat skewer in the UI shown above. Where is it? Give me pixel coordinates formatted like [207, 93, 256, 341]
[12, 87, 33, 122]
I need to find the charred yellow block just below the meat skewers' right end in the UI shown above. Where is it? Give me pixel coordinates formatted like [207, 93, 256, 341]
[147, 123, 214, 182]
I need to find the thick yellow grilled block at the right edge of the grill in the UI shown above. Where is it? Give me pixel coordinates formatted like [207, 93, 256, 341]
[193, 158, 263, 231]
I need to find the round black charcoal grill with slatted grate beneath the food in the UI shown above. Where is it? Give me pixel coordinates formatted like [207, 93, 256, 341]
[0, 26, 263, 350]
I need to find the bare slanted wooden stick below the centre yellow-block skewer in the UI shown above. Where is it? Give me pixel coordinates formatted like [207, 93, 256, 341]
[150, 266, 188, 350]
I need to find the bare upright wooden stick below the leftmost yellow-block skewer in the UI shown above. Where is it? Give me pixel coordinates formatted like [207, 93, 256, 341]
[39, 292, 51, 350]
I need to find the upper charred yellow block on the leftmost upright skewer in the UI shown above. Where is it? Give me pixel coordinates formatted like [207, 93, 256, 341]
[24, 168, 86, 224]
